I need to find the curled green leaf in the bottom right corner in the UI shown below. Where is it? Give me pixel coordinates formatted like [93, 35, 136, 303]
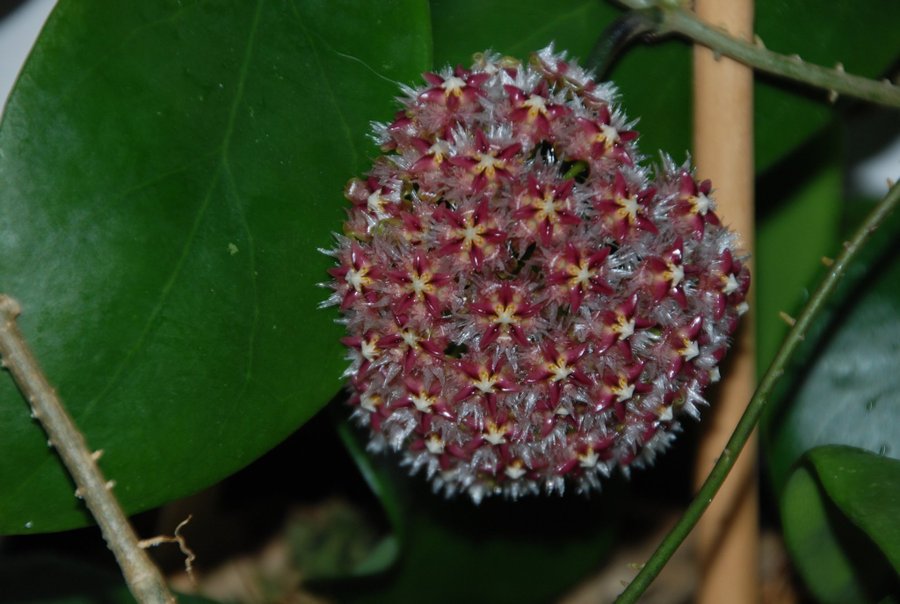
[781, 447, 900, 604]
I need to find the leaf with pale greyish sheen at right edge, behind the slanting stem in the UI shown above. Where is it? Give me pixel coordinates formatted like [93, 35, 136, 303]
[763, 202, 900, 492]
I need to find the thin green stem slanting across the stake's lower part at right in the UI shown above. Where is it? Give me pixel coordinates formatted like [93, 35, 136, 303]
[616, 183, 900, 604]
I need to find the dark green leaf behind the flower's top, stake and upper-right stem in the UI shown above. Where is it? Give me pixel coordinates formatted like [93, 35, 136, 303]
[431, 0, 900, 170]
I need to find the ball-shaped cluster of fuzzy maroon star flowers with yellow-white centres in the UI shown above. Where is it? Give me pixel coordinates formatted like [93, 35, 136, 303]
[325, 48, 749, 502]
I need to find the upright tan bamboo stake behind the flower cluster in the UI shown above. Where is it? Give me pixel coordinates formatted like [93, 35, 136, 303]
[694, 0, 760, 604]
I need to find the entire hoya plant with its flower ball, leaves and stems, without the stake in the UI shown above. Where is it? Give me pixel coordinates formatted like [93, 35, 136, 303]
[0, 0, 900, 602]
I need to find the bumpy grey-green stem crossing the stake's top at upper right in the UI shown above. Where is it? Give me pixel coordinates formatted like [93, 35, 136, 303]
[617, 0, 900, 108]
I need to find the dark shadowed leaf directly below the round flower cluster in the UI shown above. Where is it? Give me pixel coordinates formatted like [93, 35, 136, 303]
[320, 424, 624, 604]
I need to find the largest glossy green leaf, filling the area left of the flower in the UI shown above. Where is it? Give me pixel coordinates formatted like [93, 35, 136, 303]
[0, 0, 430, 533]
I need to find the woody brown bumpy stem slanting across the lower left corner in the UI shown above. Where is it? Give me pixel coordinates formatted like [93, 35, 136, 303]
[0, 294, 175, 604]
